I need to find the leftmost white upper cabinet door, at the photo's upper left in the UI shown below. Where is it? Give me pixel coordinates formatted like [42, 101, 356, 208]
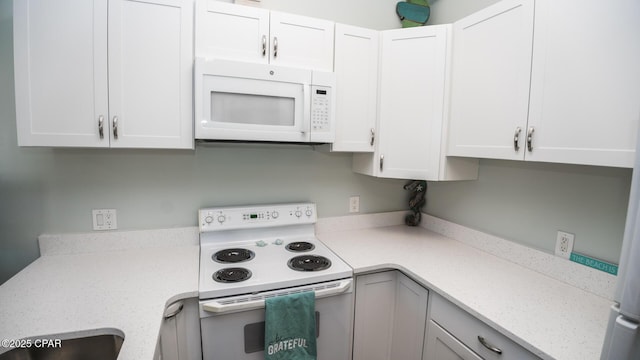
[13, 0, 109, 147]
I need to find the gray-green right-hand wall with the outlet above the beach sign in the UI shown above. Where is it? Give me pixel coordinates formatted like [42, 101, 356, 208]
[426, 0, 631, 263]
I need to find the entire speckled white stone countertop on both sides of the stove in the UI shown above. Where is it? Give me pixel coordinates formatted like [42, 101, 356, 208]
[0, 212, 615, 360]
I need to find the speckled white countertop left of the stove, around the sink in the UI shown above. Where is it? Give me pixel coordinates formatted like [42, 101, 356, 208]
[0, 229, 199, 360]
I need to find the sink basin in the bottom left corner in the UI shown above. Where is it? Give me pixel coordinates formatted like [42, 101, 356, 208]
[0, 334, 124, 360]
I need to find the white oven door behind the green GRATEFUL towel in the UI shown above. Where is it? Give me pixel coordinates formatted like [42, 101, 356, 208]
[200, 279, 353, 360]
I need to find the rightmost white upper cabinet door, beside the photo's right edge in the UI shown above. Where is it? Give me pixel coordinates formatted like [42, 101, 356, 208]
[526, 0, 640, 167]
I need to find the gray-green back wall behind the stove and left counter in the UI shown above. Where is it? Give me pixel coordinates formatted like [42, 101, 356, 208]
[0, 0, 407, 283]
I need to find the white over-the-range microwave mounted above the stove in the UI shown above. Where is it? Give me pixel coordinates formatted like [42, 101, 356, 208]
[194, 58, 335, 143]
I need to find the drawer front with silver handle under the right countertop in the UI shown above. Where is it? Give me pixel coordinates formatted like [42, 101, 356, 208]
[431, 295, 539, 360]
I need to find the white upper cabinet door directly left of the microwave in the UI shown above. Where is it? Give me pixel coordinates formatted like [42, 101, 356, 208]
[109, 0, 193, 148]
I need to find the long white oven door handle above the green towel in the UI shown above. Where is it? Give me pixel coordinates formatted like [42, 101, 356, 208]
[202, 279, 353, 314]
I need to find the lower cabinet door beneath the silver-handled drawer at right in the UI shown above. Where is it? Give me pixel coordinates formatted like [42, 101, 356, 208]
[424, 321, 482, 360]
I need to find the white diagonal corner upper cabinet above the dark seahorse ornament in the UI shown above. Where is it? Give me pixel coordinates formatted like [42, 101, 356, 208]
[352, 25, 477, 180]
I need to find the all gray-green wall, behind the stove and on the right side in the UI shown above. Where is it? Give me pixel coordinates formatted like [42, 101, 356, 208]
[0, 0, 631, 283]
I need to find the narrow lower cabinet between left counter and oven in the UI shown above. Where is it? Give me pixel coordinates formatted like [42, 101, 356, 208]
[153, 298, 202, 360]
